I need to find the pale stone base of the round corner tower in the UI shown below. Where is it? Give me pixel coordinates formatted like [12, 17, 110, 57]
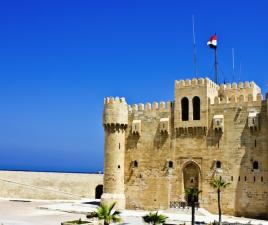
[101, 193, 126, 210]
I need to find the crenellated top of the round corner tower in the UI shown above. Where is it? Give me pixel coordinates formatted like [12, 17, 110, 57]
[103, 97, 128, 126]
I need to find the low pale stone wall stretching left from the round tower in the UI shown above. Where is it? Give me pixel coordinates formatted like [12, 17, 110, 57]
[0, 171, 103, 200]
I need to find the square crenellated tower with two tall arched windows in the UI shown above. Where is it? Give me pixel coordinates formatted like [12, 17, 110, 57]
[174, 78, 219, 129]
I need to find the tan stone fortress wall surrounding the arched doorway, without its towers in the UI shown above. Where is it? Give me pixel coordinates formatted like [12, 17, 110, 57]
[122, 85, 268, 218]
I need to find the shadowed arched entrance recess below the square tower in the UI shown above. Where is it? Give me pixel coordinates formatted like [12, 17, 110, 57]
[183, 162, 200, 203]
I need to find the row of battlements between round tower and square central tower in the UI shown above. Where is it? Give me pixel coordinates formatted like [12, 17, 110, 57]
[128, 101, 172, 113]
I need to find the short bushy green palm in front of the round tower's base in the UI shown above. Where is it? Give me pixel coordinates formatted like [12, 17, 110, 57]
[87, 203, 121, 225]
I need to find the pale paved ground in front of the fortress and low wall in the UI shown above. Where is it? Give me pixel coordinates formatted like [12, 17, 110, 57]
[0, 200, 268, 225]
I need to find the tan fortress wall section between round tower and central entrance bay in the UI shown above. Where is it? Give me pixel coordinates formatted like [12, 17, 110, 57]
[125, 103, 171, 209]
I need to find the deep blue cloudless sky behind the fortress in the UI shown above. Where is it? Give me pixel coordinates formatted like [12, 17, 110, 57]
[0, 0, 268, 172]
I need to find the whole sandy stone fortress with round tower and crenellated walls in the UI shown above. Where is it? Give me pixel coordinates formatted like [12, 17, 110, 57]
[102, 78, 268, 218]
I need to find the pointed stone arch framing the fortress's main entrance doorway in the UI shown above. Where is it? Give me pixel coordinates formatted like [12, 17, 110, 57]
[181, 160, 202, 203]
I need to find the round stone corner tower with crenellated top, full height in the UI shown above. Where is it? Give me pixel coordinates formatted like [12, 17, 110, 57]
[101, 98, 128, 209]
